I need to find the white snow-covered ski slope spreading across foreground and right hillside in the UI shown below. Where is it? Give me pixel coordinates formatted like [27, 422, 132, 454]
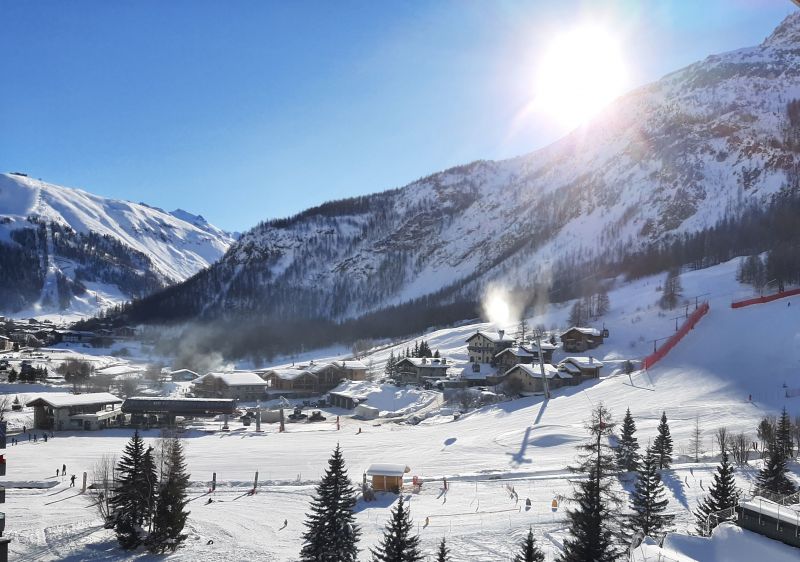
[4, 261, 800, 562]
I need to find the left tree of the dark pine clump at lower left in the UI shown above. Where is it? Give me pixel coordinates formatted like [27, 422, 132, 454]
[109, 430, 156, 549]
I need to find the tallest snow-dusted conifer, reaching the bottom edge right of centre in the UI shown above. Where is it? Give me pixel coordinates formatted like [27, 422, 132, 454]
[558, 404, 621, 562]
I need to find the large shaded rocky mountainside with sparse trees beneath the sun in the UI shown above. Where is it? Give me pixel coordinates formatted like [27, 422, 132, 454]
[114, 14, 800, 324]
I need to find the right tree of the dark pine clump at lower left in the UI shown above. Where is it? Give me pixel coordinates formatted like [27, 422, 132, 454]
[147, 439, 189, 553]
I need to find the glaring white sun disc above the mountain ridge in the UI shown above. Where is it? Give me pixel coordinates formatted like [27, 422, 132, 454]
[536, 26, 627, 127]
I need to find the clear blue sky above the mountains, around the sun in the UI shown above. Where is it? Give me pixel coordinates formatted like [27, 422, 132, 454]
[0, 0, 796, 230]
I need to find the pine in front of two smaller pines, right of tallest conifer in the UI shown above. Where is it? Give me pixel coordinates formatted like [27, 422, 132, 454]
[629, 448, 674, 538]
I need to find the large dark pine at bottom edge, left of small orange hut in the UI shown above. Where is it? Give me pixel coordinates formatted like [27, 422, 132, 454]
[300, 445, 361, 562]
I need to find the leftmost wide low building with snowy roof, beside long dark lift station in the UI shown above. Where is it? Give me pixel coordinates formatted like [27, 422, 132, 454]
[25, 392, 124, 431]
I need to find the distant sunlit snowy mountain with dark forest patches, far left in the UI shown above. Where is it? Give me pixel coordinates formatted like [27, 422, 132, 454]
[0, 173, 233, 313]
